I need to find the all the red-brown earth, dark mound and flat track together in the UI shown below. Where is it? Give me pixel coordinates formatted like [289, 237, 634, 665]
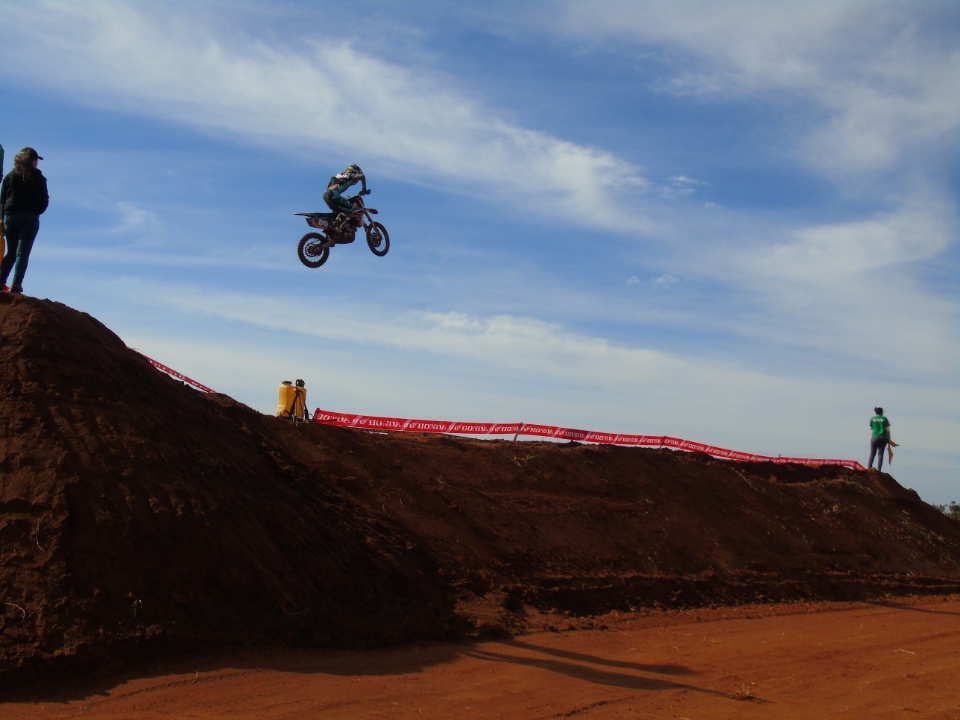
[0, 295, 960, 718]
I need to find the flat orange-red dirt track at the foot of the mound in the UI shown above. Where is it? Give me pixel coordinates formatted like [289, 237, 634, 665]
[3, 597, 960, 720]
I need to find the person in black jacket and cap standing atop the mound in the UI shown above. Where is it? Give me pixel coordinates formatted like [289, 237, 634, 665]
[0, 147, 50, 293]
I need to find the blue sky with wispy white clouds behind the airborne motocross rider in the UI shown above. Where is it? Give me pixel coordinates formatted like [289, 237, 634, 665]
[0, 0, 960, 503]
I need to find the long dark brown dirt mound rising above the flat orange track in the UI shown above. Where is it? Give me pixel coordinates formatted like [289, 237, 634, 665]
[0, 295, 960, 688]
